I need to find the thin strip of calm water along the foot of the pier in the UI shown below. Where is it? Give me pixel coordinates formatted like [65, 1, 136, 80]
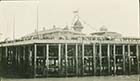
[2, 75, 140, 81]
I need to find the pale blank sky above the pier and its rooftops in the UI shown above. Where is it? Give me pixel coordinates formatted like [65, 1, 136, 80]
[0, 0, 139, 40]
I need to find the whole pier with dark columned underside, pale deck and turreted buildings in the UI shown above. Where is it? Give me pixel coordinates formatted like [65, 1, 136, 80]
[0, 17, 140, 77]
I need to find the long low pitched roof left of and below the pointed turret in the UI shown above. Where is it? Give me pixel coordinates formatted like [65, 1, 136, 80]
[22, 27, 85, 39]
